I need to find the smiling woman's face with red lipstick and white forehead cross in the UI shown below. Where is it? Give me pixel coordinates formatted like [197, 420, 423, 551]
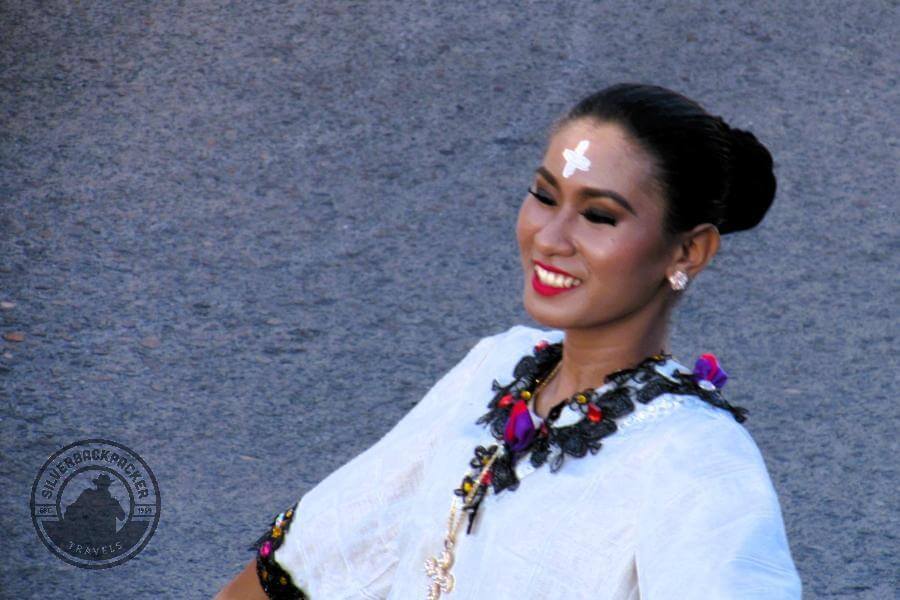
[516, 119, 674, 329]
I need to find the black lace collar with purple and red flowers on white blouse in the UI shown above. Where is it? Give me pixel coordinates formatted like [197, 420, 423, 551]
[454, 340, 748, 534]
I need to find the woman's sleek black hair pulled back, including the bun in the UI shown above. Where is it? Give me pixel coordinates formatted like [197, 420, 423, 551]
[554, 83, 775, 237]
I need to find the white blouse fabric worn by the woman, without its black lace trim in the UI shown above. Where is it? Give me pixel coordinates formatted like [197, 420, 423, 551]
[262, 325, 801, 600]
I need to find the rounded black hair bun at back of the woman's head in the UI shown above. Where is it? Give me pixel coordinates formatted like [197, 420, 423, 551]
[718, 127, 776, 234]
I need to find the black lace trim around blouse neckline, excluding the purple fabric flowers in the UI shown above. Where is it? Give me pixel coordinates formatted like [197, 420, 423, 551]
[454, 342, 748, 533]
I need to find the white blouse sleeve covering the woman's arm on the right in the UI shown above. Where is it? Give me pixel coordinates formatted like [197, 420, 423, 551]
[635, 416, 801, 600]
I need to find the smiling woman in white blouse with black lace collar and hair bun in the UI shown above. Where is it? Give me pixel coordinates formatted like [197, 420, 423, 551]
[220, 84, 801, 600]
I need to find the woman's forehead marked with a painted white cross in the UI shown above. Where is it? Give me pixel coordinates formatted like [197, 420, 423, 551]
[543, 119, 653, 202]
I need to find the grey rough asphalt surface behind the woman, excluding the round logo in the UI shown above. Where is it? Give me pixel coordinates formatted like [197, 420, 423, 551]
[0, 0, 900, 599]
